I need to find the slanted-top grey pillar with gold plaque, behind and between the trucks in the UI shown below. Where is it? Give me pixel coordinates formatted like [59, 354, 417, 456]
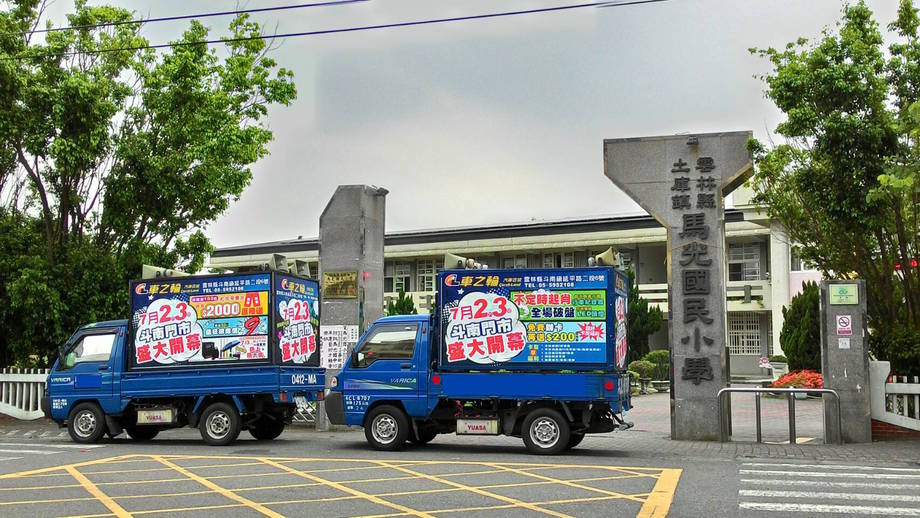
[316, 185, 388, 430]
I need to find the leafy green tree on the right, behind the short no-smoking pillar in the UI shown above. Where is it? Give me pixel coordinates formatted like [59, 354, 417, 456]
[750, 0, 920, 369]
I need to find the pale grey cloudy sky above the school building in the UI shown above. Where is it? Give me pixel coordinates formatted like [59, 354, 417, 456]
[37, 0, 897, 246]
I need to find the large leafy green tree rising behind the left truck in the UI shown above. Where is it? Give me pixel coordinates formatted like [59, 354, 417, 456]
[0, 0, 296, 362]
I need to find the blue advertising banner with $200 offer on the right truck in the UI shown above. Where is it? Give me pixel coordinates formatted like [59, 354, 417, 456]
[439, 267, 626, 370]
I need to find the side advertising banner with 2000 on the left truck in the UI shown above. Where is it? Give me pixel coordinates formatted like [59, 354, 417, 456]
[131, 273, 271, 367]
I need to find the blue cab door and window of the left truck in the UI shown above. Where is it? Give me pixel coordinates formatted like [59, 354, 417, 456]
[49, 328, 124, 415]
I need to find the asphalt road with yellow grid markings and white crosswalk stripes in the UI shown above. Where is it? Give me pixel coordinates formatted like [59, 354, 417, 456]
[0, 421, 920, 518]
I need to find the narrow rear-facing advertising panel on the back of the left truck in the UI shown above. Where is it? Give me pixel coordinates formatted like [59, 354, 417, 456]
[273, 274, 319, 367]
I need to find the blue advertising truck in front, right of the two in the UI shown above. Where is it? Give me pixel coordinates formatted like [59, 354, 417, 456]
[325, 267, 631, 454]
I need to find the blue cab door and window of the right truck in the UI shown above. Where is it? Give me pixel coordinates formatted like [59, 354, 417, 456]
[344, 323, 426, 416]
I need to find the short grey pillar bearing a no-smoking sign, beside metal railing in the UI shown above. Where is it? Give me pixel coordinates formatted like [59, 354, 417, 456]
[820, 280, 872, 442]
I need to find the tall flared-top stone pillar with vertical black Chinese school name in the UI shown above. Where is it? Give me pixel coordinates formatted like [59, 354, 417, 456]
[604, 132, 752, 441]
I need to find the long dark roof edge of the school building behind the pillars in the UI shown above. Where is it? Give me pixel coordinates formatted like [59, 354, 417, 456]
[211, 209, 744, 257]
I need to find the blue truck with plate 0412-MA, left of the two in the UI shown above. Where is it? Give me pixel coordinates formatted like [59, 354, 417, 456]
[42, 272, 325, 445]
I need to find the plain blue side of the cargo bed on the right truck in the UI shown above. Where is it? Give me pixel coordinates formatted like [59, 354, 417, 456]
[430, 372, 629, 411]
